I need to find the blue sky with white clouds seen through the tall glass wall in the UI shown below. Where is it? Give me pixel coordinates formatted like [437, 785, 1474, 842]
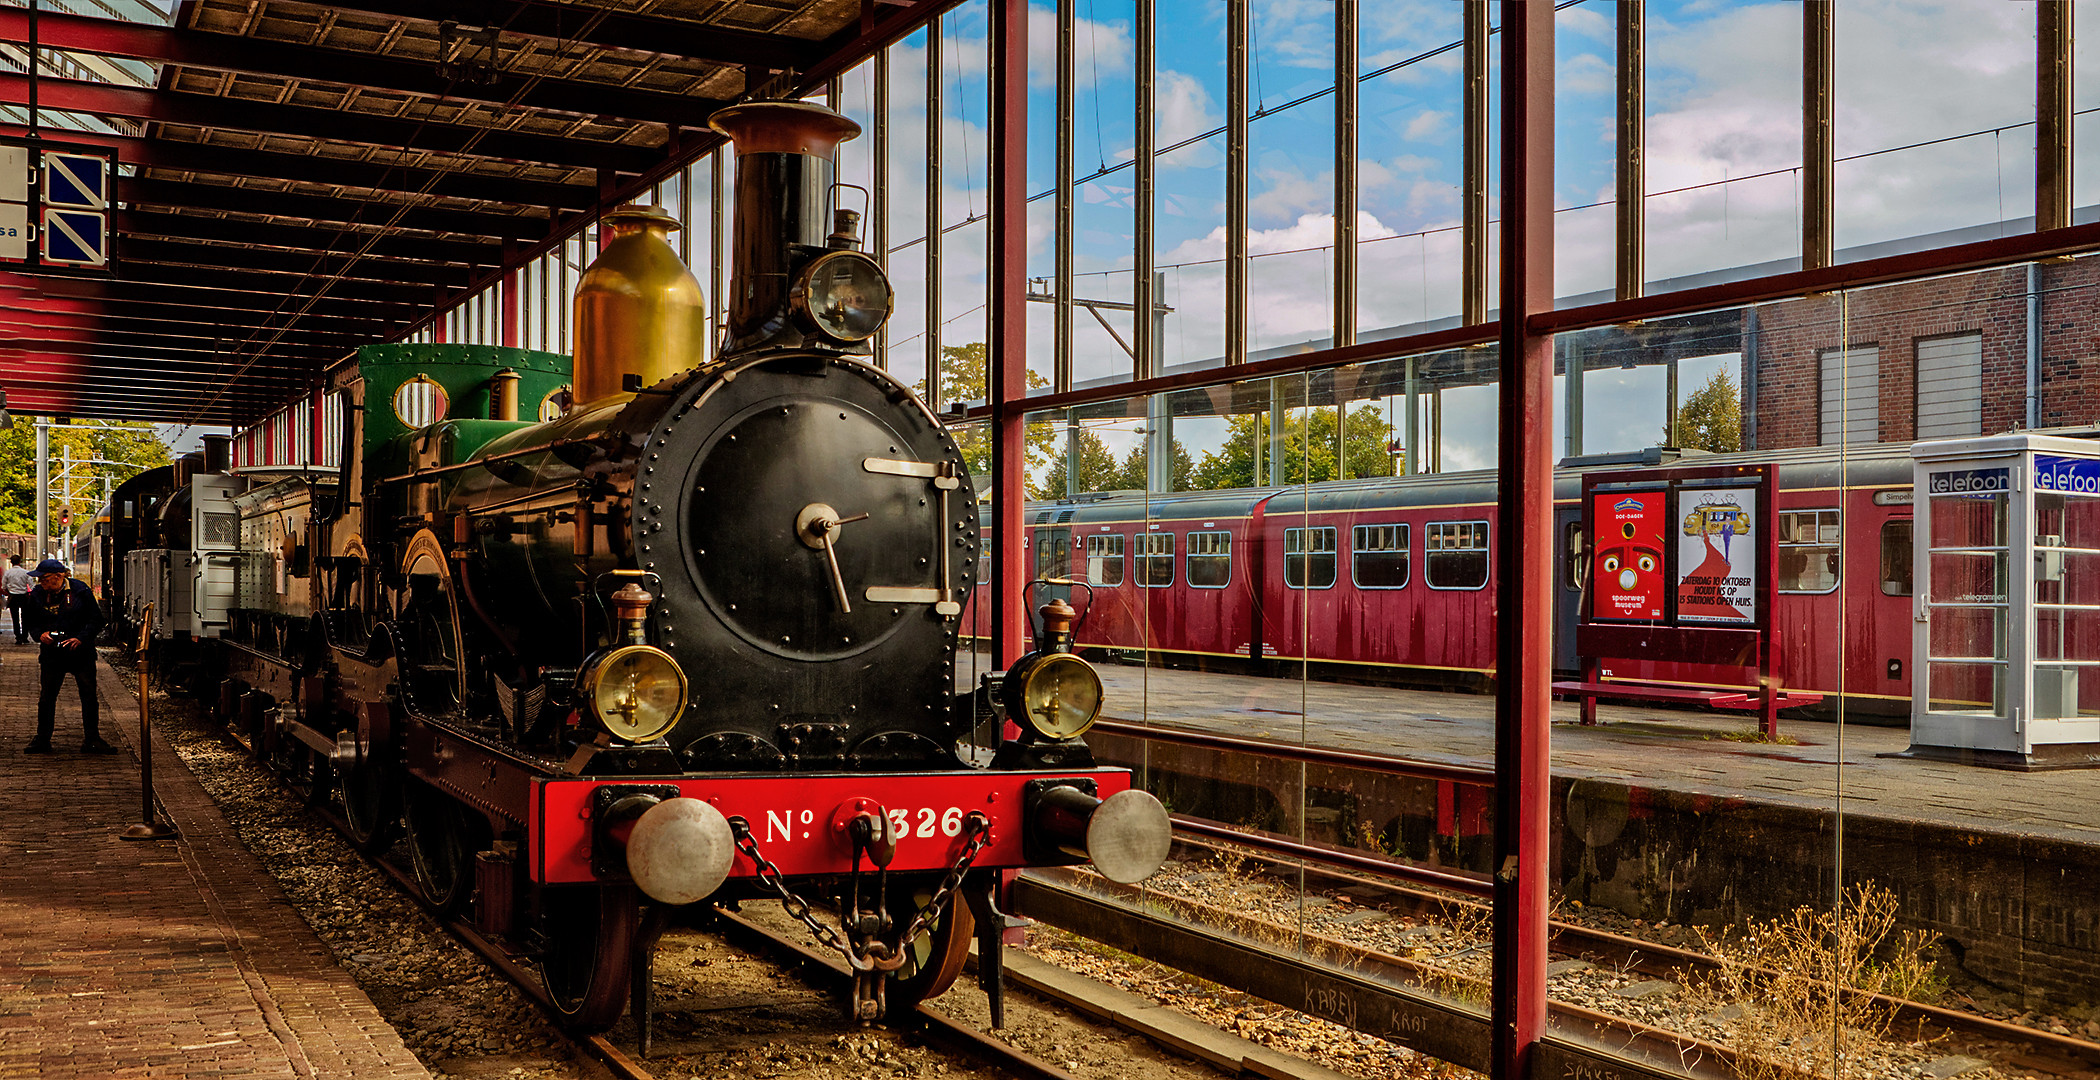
[810, 0, 2074, 469]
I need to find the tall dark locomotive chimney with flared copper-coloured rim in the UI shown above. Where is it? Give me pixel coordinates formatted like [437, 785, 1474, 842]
[708, 101, 861, 349]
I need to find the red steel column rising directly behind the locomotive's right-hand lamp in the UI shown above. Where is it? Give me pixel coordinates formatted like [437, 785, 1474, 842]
[985, 0, 1029, 668]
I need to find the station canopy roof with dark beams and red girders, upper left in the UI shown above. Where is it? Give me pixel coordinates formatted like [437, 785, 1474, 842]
[0, 0, 936, 424]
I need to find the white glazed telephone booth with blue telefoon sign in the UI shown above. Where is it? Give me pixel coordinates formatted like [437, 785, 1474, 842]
[1909, 435, 2100, 769]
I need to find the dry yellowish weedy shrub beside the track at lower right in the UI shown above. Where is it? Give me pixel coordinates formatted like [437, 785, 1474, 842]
[1691, 882, 1943, 1080]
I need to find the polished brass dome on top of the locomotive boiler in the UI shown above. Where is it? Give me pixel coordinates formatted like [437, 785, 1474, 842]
[571, 206, 708, 403]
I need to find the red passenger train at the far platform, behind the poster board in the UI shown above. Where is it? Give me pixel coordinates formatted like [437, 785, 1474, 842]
[991, 445, 1911, 716]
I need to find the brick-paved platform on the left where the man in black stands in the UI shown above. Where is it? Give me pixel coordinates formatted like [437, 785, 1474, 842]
[0, 635, 428, 1080]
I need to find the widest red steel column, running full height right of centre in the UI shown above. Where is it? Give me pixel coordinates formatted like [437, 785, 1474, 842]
[1491, 4, 1554, 1080]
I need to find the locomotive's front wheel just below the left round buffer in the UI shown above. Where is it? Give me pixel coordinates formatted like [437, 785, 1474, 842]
[540, 885, 641, 1032]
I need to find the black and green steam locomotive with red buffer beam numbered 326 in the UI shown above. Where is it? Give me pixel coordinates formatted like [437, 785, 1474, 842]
[111, 101, 1170, 1032]
